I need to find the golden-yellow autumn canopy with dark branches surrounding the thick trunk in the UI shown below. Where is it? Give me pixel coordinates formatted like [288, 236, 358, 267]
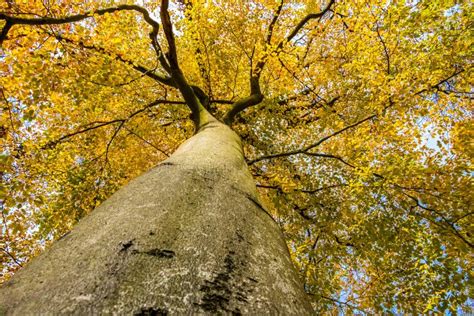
[0, 0, 474, 313]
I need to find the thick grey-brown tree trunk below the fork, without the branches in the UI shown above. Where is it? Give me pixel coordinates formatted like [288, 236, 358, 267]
[0, 121, 311, 315]
